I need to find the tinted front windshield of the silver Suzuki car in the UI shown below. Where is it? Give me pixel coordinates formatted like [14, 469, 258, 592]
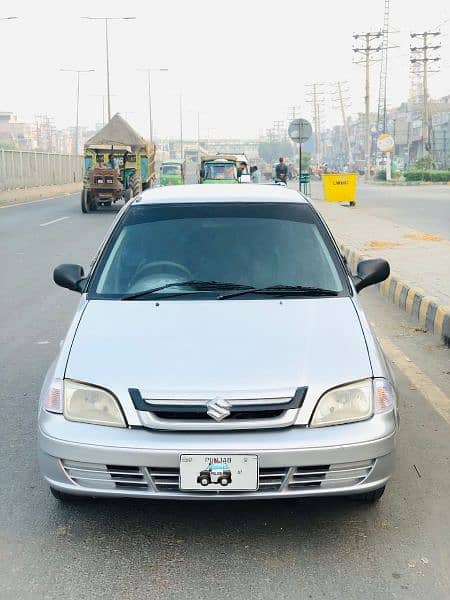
[88, 202, 348, 300]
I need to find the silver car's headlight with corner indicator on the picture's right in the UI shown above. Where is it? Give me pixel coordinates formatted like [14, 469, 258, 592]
[310, 378, 395, 427]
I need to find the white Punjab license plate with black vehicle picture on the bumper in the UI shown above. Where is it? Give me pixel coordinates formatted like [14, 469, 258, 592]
[180, 454, 258, 492]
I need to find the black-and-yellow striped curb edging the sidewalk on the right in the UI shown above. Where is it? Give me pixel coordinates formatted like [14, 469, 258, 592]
[341, 244, 450, 347]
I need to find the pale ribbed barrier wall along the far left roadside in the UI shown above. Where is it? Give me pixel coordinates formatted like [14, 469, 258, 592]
[0, 150, 83, 190]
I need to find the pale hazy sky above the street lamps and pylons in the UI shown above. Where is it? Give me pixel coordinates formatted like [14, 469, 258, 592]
[0, 0, 450, 138]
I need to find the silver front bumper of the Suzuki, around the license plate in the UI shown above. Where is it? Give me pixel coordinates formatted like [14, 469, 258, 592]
[38, 411, 397, 500]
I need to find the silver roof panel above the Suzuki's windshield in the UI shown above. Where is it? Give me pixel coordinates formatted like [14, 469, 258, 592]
[133, 183, 308, 205]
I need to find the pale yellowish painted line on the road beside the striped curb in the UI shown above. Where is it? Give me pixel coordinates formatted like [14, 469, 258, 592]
[379, 338, 450, 423]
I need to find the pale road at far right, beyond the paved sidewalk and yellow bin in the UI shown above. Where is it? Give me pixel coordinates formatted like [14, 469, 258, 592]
[312, 182, 450, 239]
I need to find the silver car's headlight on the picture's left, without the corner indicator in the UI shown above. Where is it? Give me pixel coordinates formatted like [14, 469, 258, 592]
[64, 379, 127, 427]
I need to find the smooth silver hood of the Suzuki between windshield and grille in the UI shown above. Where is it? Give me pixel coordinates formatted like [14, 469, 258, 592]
[65, 297, 372, 398]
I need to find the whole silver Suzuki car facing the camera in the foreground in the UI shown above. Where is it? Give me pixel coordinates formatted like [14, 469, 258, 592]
[38, 185, 398, 502]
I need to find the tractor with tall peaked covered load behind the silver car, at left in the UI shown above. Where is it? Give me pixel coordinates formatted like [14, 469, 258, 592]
[81, 114, 155, 213]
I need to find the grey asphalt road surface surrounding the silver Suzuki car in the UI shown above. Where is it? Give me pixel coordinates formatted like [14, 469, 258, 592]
[0, 191, 450, 600]
